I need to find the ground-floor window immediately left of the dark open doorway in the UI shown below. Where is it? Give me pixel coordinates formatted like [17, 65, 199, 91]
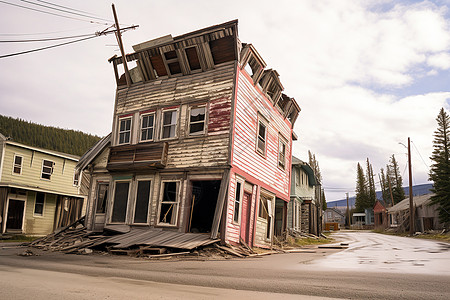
[158, 181, 179, 225]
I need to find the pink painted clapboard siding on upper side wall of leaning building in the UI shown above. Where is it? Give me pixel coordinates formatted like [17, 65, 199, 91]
[232, 67, 292, 201]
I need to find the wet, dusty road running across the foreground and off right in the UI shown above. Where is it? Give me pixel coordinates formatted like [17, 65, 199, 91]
[0, 232, 450, 299]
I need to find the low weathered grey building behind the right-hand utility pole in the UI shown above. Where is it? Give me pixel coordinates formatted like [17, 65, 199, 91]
[387, 194, 443, 232]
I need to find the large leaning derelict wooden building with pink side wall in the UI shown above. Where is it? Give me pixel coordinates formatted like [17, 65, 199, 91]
[79, 20, 300, 247]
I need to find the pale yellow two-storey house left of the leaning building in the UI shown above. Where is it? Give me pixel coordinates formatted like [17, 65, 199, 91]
[0, 134, 87, 236]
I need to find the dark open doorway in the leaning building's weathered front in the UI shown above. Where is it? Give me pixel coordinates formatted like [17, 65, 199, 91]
[187, 180, 221, 233]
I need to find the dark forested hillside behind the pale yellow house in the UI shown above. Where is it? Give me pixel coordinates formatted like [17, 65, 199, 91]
[0, 115, 100, 156]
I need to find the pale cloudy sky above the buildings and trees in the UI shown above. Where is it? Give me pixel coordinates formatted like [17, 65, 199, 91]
[0, 0, 450, 201]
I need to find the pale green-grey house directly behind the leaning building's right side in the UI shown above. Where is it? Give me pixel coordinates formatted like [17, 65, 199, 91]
[287, 156, 322, 235]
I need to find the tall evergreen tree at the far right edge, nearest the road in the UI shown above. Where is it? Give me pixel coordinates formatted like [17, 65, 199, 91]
[430, 108, 450, 228]
